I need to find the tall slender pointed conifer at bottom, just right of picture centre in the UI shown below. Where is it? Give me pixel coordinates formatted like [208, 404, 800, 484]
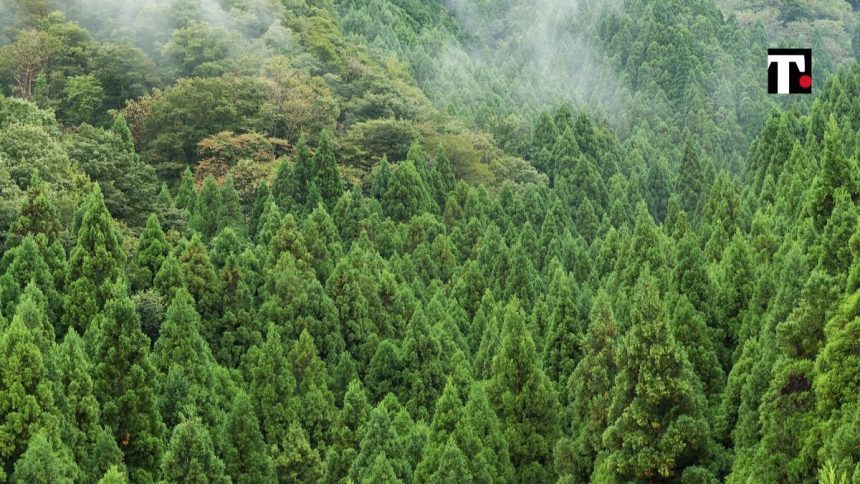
[489, 300, 561, 482]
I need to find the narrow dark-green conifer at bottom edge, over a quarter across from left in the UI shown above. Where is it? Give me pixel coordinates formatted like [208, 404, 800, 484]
[224, 391, 275, 484]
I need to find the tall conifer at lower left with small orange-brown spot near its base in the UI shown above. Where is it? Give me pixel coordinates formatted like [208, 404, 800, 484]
[90, 280, 166, 480]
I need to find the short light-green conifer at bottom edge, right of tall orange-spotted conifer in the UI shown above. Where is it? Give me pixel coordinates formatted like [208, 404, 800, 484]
[161, 418, 230, 484]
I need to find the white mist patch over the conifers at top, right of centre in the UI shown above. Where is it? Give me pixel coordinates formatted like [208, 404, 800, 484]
[426, 0, 627, 125]
